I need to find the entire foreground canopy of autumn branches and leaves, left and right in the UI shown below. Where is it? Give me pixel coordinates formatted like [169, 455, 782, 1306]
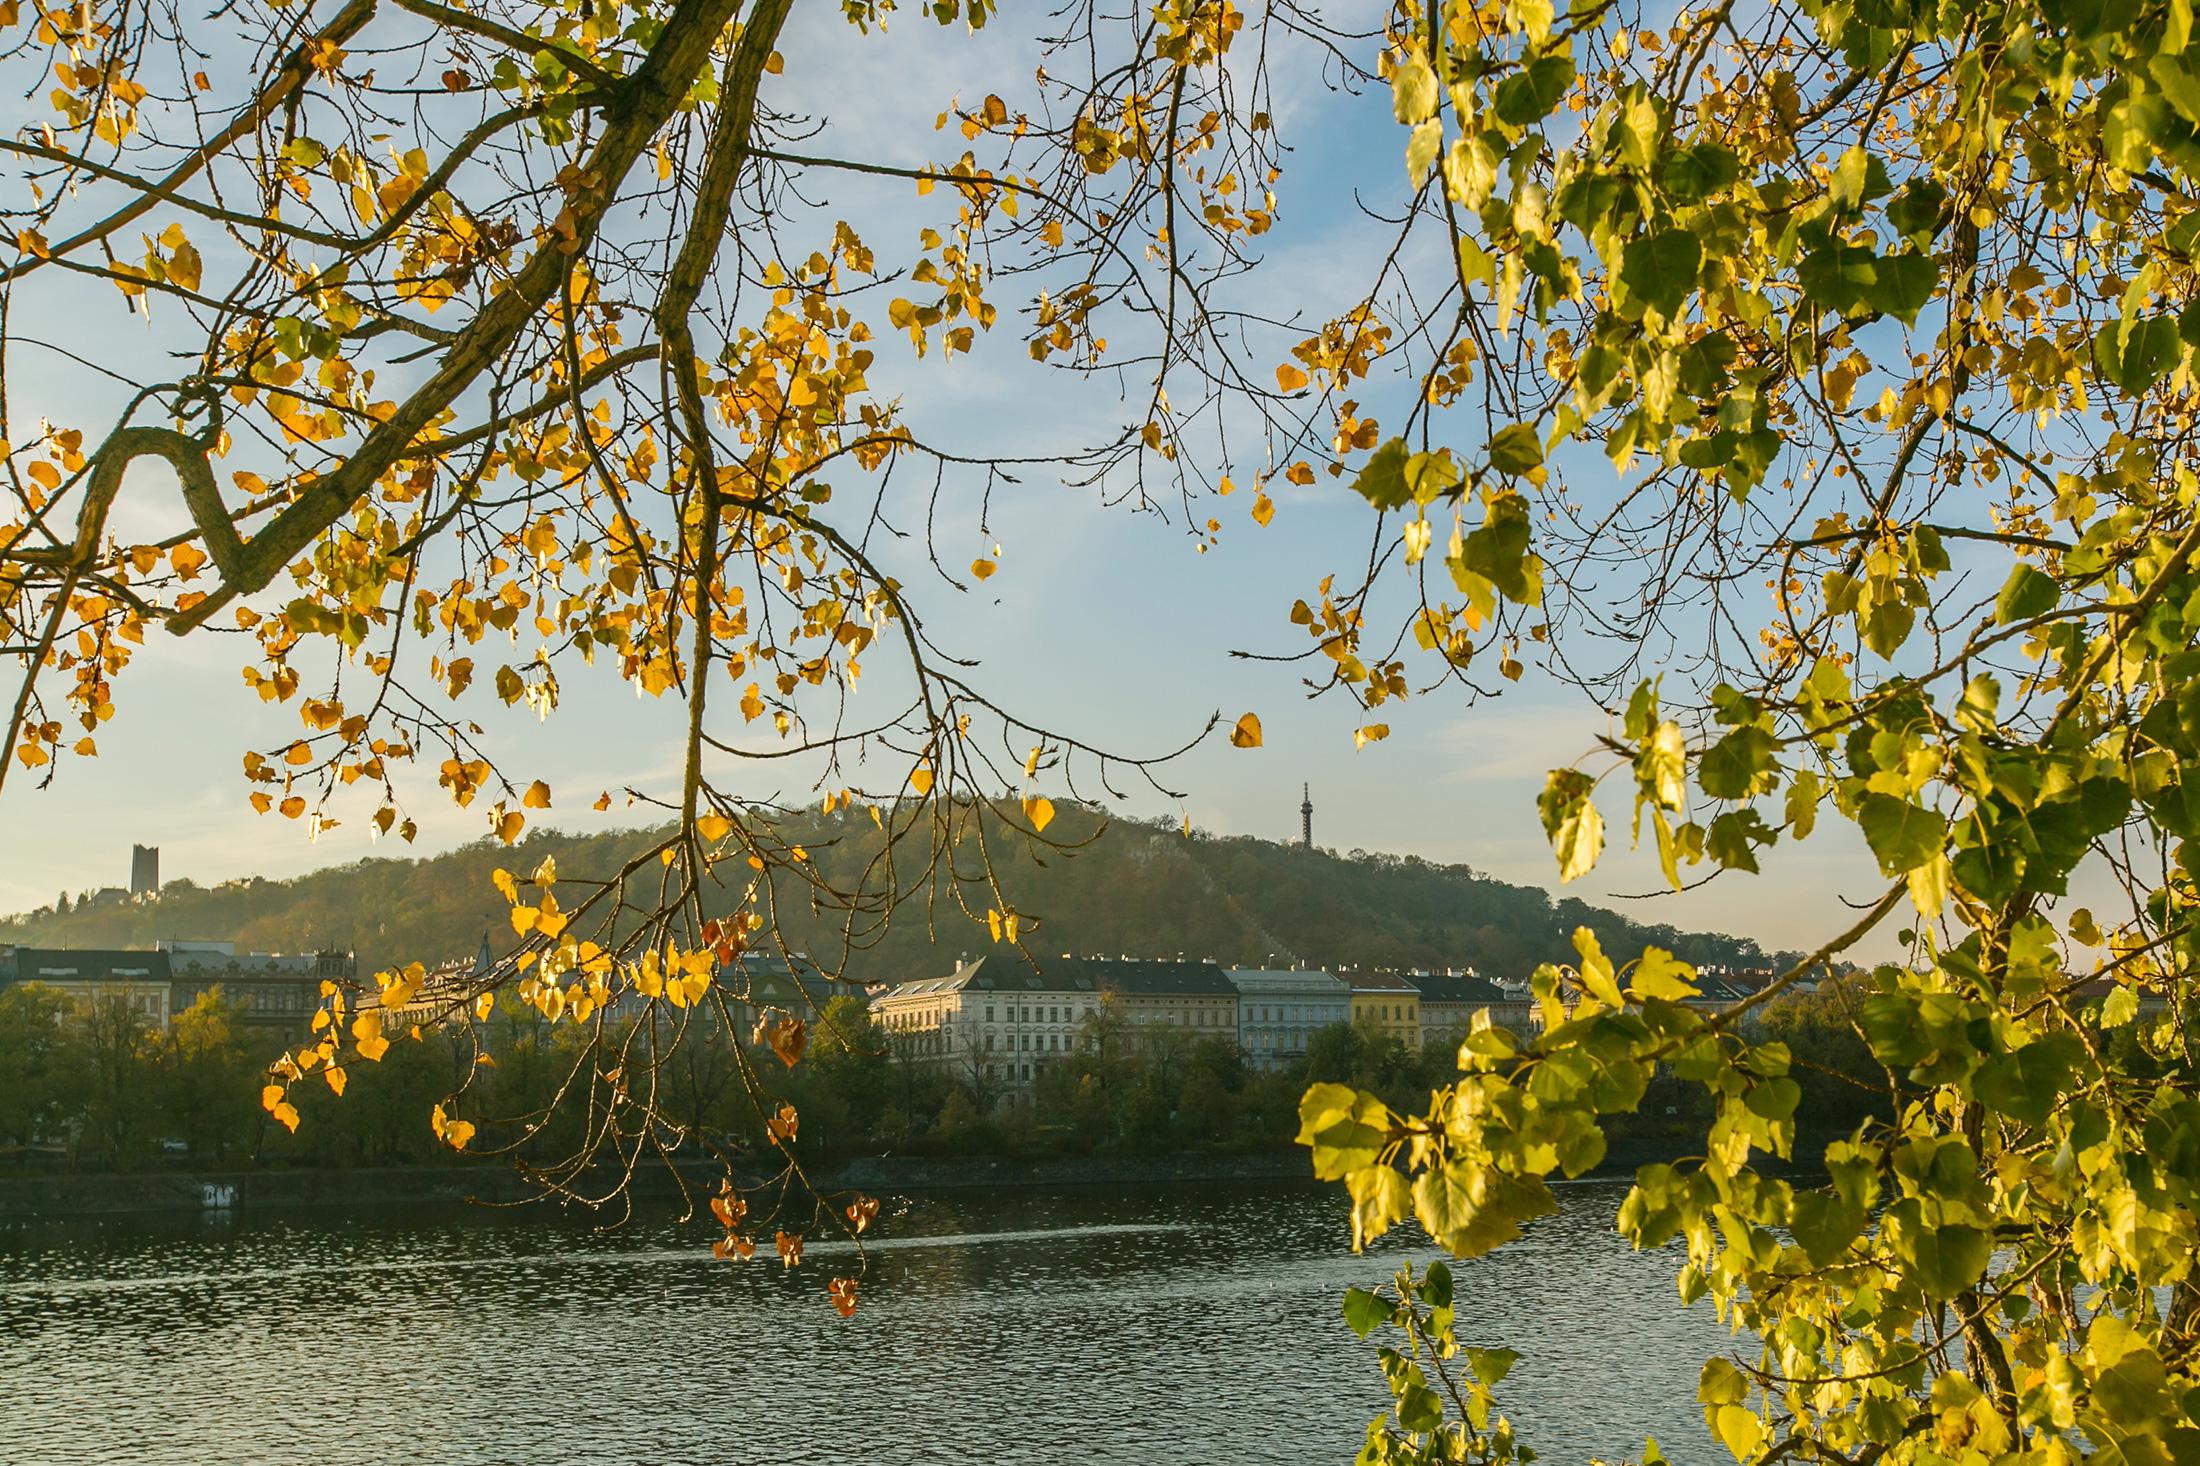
[0, 0, 2200, 1443]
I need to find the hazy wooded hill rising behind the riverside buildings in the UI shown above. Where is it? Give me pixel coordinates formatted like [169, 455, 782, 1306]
[0, 806, 1793, 982]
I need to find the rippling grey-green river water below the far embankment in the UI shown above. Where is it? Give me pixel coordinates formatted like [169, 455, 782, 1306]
[0, 1182, 1729, 1466]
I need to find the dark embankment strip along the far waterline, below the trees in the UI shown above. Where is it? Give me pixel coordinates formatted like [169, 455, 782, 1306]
[0, 1136, 1830, 1222]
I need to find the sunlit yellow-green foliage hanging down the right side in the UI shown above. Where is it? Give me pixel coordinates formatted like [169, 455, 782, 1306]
[1280, 0, 2200, 1466]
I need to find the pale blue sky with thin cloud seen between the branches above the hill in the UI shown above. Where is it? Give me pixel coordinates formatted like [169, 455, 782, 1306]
[0, 7, 1927, 949]
